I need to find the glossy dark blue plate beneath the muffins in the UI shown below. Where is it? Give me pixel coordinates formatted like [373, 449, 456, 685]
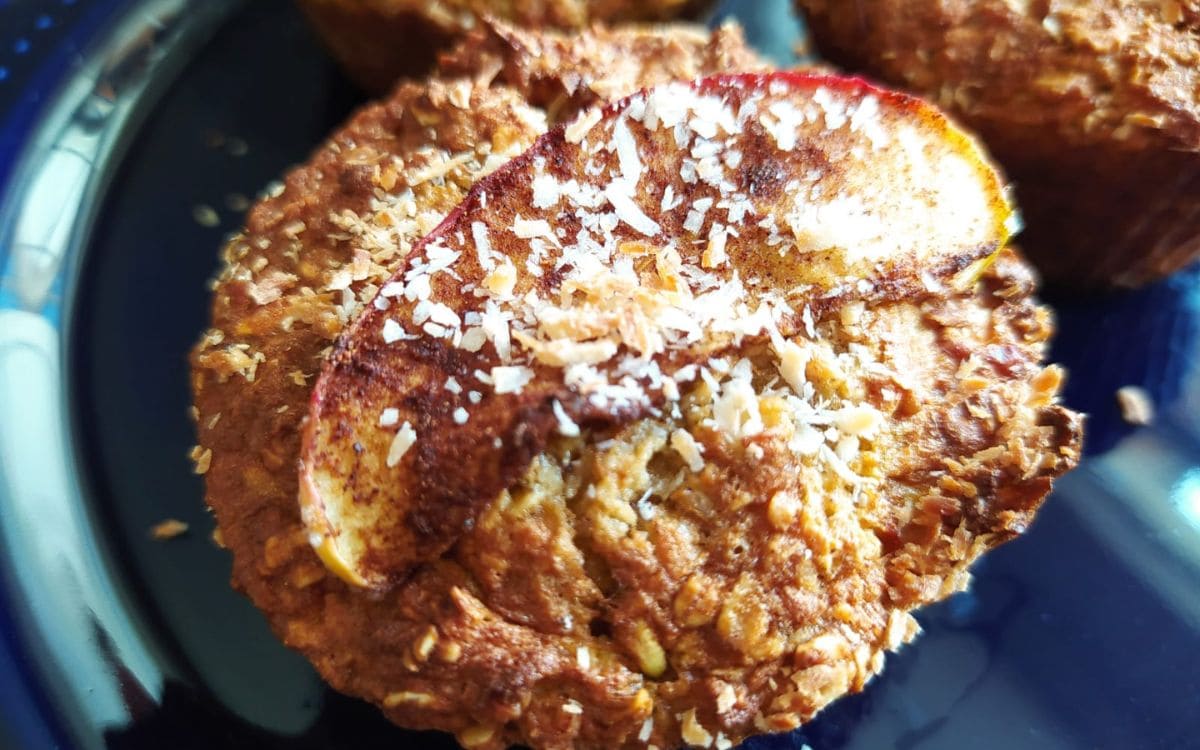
[0, 0, 1200, 750]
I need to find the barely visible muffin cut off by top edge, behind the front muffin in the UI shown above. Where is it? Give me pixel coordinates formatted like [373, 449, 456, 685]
[299, 0, 709, 92]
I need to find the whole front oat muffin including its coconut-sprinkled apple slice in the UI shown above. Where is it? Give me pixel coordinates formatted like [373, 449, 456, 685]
[192, 27, 1080, 748]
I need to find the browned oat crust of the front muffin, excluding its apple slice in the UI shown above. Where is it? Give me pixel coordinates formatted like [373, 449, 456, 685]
[193, 37, 1079, 748]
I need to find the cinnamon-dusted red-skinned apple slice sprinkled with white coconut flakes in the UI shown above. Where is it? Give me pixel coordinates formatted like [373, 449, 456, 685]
[300, 73, 1016, 588]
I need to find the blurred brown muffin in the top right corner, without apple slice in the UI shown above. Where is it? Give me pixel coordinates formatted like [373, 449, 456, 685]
[797, 0, 1200, 287]
